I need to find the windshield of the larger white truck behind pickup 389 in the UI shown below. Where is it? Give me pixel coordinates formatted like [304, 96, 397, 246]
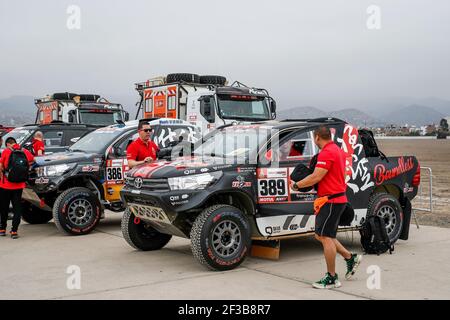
[218, 95, 272, 121]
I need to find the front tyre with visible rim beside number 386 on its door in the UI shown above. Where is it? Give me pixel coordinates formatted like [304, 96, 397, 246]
[53, 187, 103, 235]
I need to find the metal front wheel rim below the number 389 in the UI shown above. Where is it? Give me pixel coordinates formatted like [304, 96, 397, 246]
[212, 220, 242, 258]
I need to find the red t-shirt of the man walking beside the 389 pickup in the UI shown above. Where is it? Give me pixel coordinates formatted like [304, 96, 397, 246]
[316, 142, 348, 203]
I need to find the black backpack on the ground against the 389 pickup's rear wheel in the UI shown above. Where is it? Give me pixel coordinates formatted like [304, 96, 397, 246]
[359, 215, 394, 255]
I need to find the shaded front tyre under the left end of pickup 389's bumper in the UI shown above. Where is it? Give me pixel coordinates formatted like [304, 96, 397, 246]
[121, 209, 172, 251]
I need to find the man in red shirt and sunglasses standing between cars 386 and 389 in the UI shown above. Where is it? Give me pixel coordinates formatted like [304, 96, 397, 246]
[127, 121, 159, 169]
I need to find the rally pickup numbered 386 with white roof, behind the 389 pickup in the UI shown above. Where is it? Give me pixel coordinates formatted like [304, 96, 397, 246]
[22, 119, 200, 235]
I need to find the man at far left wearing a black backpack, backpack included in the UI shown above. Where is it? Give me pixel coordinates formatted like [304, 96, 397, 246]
[0, 137, 34, 239]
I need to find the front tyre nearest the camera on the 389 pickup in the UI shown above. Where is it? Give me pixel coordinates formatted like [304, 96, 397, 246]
[190, 205, 251, 271]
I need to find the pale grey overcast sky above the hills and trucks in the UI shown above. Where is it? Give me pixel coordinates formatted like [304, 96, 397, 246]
[0, 0, 450, 109]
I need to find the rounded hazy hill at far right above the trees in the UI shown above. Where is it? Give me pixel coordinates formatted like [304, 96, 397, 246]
[383, 105, 446, 126]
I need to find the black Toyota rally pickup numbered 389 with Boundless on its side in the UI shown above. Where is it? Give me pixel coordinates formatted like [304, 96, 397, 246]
[121, 119, 420, 270]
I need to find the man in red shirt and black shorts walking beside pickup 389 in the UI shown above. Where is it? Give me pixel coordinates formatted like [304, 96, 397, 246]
[292, 126, 362, 289]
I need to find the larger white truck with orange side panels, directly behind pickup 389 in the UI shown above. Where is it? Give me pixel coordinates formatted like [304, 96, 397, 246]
[136, 73, 276, 134]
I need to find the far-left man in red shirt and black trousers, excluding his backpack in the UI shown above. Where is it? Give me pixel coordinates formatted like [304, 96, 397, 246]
[0, 137, 34, 239]
